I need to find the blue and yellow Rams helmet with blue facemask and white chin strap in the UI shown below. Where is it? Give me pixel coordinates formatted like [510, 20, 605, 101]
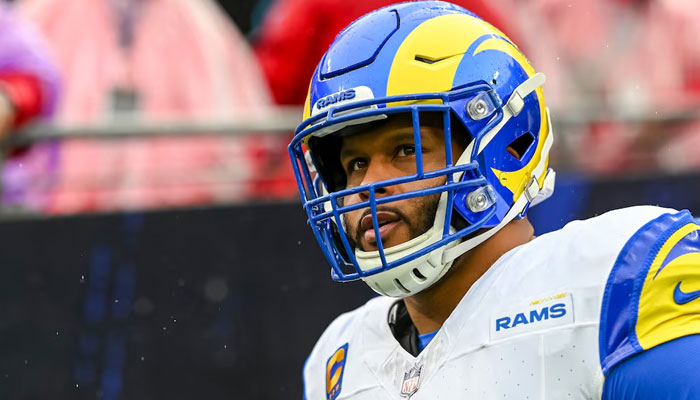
[289, 1, 554, 297]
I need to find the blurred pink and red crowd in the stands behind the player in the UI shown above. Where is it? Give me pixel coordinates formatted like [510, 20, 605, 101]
[0, 0, 700, 214]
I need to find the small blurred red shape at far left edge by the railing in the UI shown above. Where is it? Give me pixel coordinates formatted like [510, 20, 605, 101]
[0, 71, 44, 128]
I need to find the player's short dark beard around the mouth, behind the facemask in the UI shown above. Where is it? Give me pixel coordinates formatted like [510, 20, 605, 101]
[348, 193, 440, 251]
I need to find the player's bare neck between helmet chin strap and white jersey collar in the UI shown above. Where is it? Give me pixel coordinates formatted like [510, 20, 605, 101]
[404, 218, 534, 334]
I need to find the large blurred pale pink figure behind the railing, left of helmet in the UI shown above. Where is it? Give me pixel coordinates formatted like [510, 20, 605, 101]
[15, 0, 282, 214]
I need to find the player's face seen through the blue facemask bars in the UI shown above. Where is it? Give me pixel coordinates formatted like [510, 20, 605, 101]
[340, 120, 464, 251]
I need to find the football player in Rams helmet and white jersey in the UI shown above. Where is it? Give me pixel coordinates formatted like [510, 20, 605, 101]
[289, 1, 700, 400]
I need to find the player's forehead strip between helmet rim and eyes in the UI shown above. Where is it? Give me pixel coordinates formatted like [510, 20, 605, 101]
[340, 115, 445, 157]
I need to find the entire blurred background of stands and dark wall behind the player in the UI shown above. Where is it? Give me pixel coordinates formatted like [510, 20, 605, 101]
[0, 0, 700, 400]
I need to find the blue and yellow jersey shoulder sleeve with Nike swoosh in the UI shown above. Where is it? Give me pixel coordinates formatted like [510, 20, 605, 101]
[599, 211, 700, 376]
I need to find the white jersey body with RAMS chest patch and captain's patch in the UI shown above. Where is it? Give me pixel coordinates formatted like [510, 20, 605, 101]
[304, 206, 700, 400]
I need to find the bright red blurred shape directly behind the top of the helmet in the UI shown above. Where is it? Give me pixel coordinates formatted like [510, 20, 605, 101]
[255, 0, 518, 105]
